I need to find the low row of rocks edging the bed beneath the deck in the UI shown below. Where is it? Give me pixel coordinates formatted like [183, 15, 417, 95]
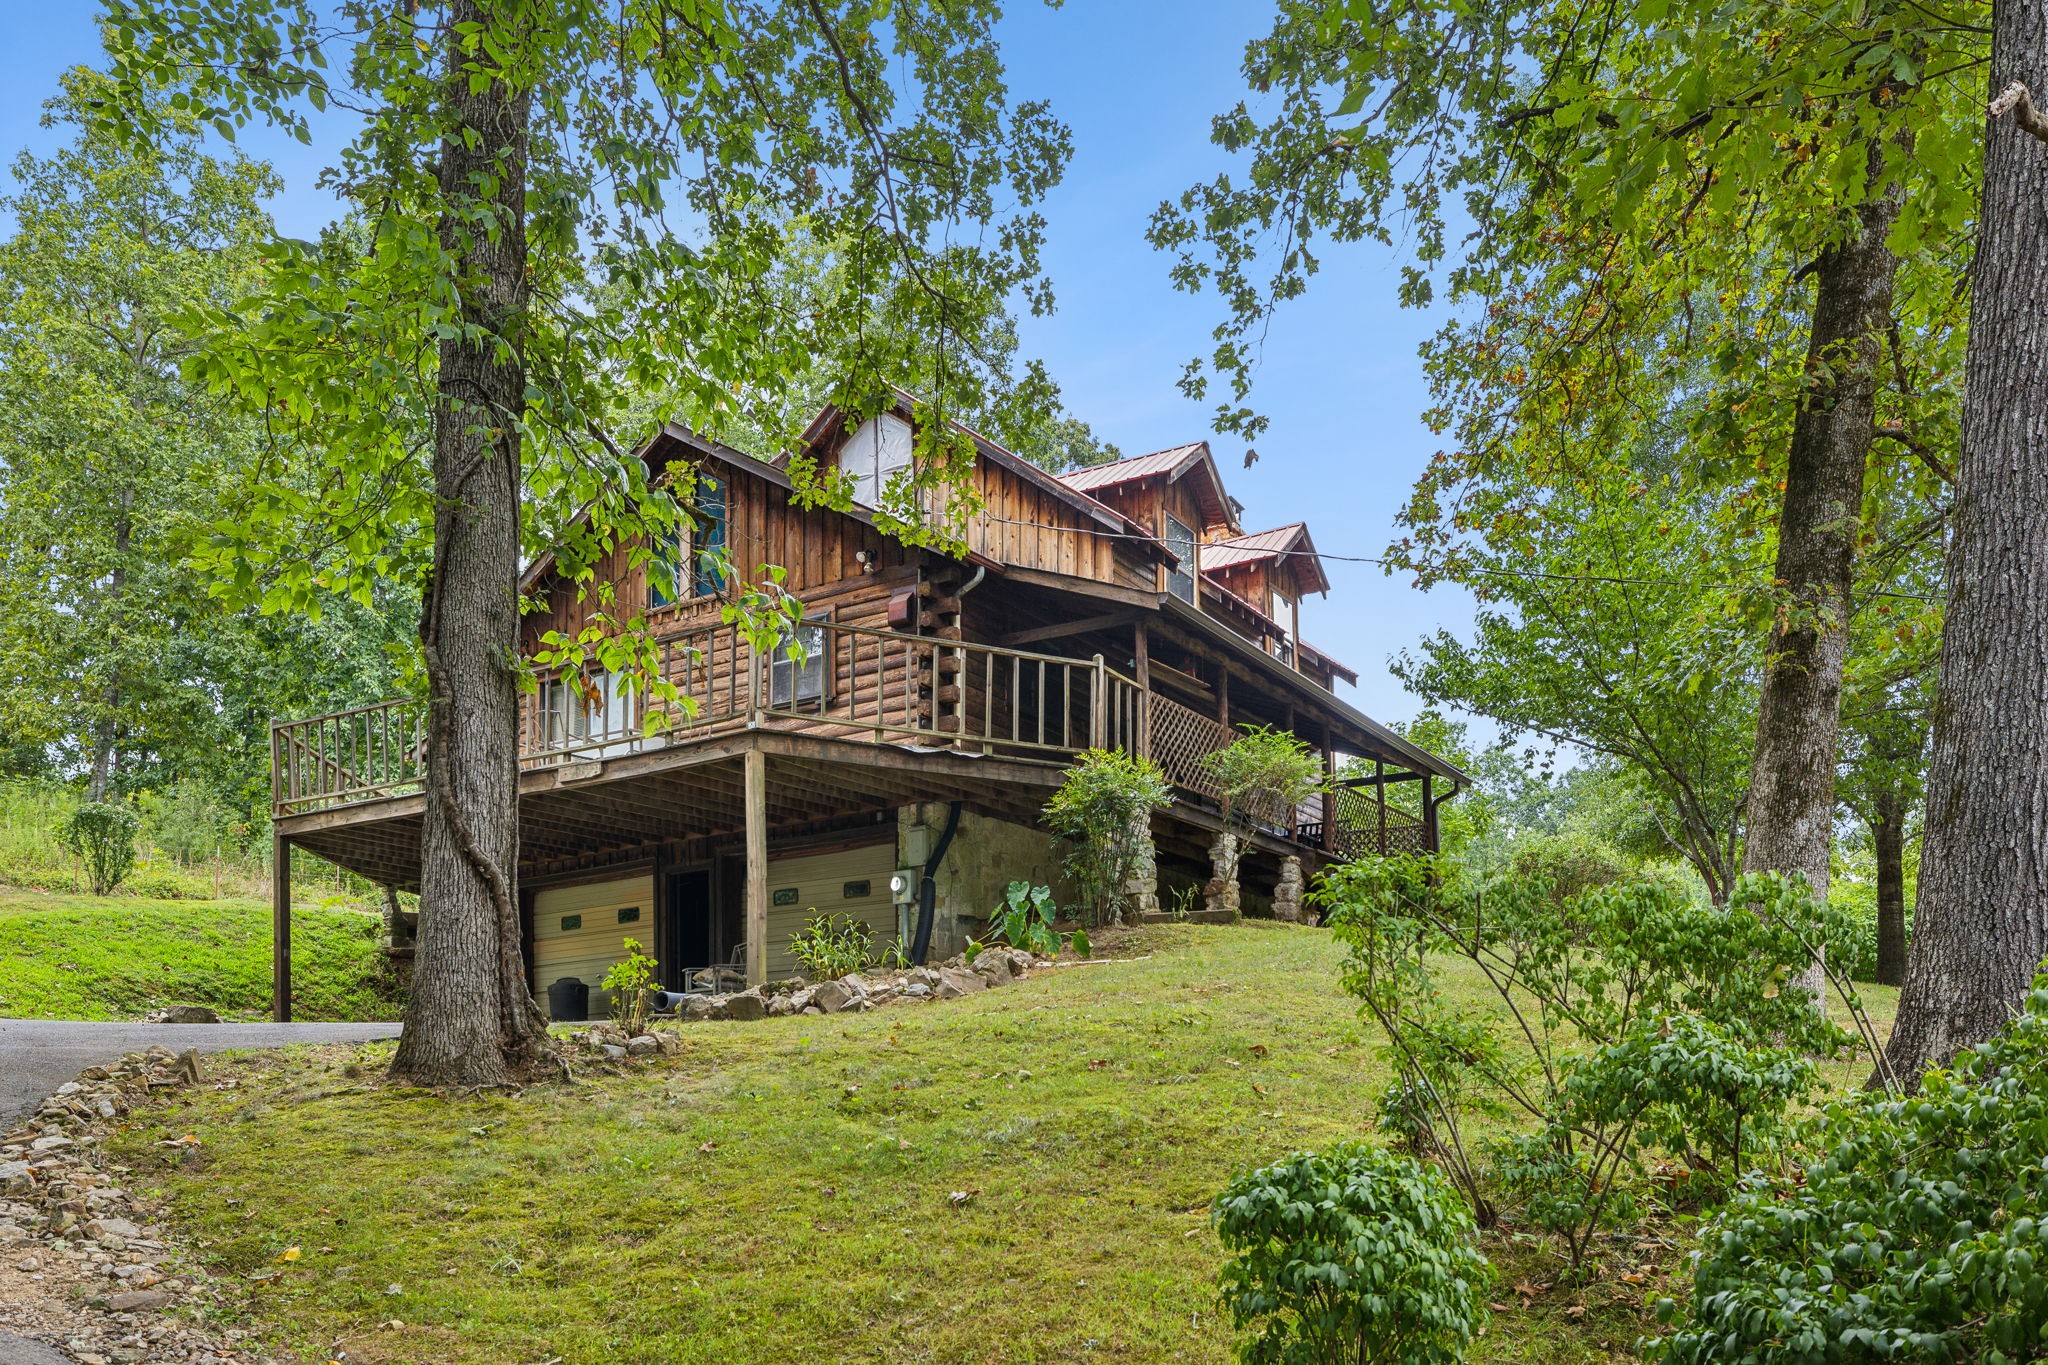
[571, 945, 1053, 1062]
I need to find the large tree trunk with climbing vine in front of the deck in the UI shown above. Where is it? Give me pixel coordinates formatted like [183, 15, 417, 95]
[391, 0, 547, 1085]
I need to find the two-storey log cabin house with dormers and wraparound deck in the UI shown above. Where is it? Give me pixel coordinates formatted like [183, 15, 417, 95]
[272, 399, 1466, 1017]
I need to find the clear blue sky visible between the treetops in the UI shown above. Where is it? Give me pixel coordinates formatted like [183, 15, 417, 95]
[0, 0, 1473, 720]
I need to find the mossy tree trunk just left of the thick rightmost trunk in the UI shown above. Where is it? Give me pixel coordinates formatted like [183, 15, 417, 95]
[1743, 147, 1898, 1003]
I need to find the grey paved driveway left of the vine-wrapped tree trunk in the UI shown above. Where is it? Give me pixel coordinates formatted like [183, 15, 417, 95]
[0, 1019, 397, 1124]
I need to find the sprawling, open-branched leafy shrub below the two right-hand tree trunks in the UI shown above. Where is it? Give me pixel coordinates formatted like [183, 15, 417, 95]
[1319, 857, 1868, 1267]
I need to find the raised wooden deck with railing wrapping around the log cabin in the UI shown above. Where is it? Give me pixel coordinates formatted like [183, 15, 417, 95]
[270, 622, 1427, 886]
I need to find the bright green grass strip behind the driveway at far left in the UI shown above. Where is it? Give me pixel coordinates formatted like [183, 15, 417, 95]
[0, 886, 399, 1021]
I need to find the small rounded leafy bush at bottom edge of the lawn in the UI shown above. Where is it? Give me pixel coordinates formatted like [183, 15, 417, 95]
[1212, 1144, 1491, 1365]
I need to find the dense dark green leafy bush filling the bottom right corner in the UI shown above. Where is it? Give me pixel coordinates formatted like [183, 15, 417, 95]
[1657, 976, 2048, 1365]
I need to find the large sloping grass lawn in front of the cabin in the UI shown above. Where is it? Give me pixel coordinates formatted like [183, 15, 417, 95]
[103, 923, 1892, 1365]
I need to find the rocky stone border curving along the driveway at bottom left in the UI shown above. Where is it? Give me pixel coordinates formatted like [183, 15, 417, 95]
[0, 1048, 276, 1365]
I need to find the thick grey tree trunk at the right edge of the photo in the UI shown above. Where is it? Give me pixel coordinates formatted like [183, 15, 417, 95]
[1888, 26, 2048, 1083]
